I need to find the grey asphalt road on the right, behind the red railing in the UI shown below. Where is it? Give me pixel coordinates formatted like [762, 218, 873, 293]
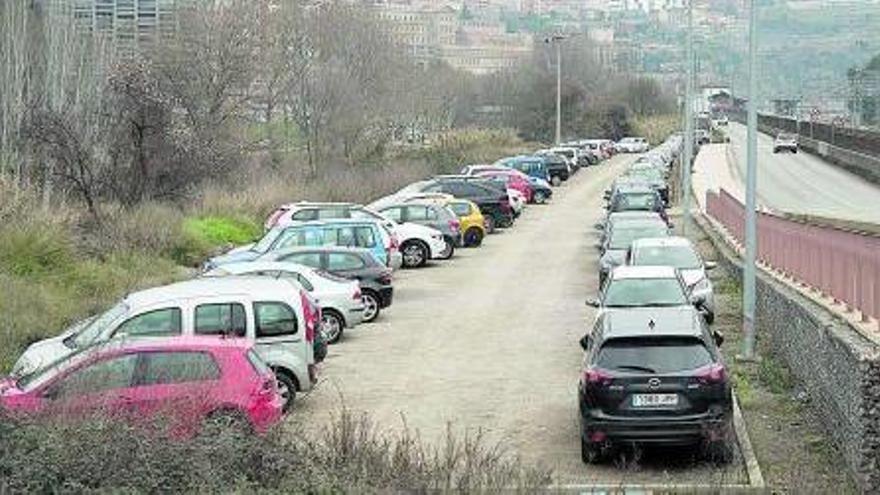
[715, 122, 880, 224]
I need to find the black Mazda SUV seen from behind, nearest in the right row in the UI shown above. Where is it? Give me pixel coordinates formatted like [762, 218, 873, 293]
[578, 306, 733, 463]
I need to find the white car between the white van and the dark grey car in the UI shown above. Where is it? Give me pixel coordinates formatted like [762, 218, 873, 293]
[204, 261, 366, 344]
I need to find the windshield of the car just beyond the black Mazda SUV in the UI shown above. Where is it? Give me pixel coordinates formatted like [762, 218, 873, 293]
[603, 278, 688, 308]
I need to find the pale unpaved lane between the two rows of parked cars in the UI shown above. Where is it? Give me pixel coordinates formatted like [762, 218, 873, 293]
[289, 156, 746, 485]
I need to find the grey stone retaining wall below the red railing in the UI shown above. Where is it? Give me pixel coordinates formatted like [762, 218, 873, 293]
[697, 216, 880, 493]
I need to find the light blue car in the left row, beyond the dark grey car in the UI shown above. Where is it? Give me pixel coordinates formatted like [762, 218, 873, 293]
[204, 219, 394, 271]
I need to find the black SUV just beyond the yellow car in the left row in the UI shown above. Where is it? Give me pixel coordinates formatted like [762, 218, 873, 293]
[396, 179, 514, 234]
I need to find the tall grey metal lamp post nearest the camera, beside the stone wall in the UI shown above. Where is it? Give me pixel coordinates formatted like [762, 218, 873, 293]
[741, 0, 758, 360]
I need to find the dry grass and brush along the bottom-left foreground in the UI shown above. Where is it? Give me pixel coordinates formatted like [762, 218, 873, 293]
[0, 411, 551, 493]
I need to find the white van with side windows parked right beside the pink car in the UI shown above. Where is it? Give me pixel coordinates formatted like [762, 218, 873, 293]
[13, 277, 320, 410]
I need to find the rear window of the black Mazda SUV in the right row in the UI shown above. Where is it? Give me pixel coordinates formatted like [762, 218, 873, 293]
[596, 340, 714, 374]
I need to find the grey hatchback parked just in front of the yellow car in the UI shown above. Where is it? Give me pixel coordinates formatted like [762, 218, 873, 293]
[379, 199, 461, 268]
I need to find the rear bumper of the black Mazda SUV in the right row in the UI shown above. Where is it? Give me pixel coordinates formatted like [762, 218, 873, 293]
[581, 412, 731, 445]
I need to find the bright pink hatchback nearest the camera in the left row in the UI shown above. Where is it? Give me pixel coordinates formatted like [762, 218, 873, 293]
[0, 337, 283, 436]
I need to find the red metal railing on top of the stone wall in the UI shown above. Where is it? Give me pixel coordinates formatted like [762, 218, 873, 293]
[706, 189, 880, 321]
